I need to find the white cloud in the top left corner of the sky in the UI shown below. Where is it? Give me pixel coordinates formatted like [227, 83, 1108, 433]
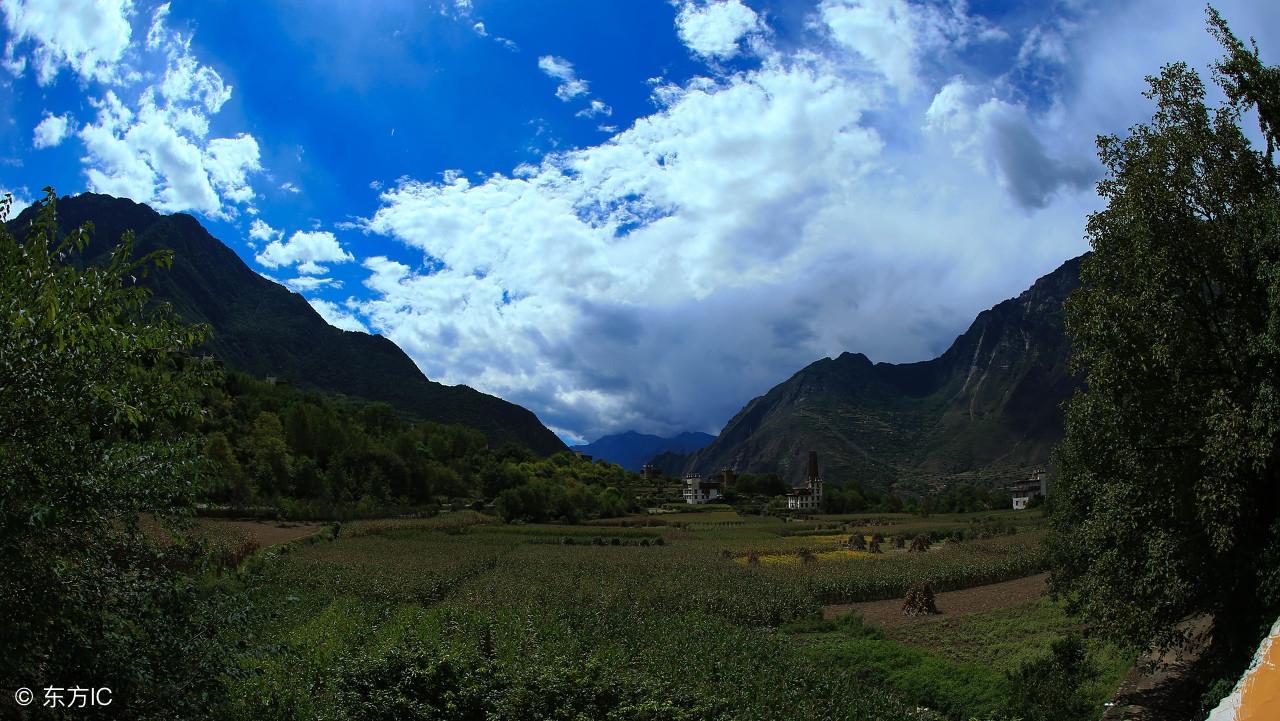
[3, 0, 133, 86]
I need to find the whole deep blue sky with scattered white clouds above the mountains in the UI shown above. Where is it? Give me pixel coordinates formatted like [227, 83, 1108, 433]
[0, 0, 1280, 441]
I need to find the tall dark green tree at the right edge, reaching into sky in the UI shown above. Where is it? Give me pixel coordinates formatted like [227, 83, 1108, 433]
[1051, 10, 1280, 645]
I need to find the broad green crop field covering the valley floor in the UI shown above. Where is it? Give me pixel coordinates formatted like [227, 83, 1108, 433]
[220, 511, 1131, 720]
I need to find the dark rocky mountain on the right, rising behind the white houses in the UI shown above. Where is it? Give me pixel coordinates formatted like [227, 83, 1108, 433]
[685, 256, 1083, 490]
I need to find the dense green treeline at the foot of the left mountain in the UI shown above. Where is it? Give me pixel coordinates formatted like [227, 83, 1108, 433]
[202, 371, 634, 523]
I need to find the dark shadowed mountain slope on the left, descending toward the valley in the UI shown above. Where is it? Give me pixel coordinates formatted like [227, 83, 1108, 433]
[10, 193, 564, 455]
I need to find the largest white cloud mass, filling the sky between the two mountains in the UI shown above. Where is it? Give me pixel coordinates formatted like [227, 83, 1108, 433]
[358, 40, 1092, 437]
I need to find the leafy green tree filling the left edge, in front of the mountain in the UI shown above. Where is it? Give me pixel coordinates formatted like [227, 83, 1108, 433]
[0, 188, 223, 718]
